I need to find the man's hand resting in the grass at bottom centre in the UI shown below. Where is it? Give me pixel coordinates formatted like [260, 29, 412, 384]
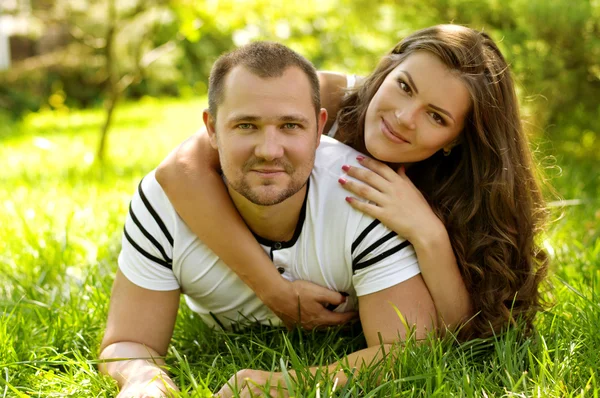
[216, 369, 290, 398]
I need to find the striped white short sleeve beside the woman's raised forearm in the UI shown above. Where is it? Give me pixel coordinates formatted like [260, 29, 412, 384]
[351, 217, 421, 296]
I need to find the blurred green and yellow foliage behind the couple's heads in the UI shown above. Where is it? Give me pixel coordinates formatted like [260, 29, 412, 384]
[0, 0, 600, 152]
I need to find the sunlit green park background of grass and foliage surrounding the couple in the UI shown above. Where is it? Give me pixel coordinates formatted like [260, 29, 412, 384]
[0, 0, 600, 397]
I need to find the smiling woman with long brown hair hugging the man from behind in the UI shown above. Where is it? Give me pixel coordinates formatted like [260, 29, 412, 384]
[156, 25, 547, 338]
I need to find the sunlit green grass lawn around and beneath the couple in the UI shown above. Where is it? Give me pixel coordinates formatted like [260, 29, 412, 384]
[0, 99, 600, 397]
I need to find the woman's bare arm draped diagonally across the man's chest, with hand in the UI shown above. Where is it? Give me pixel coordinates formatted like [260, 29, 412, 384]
[156, 130, 355, 329]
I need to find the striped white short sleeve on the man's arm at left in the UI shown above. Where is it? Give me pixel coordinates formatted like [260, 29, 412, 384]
[118, 172, 180, 291]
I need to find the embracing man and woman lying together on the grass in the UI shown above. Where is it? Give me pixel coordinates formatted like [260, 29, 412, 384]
[100, 25, 548, 397]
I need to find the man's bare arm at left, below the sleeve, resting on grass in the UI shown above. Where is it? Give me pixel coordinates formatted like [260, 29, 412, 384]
[99, 270, 180, 397]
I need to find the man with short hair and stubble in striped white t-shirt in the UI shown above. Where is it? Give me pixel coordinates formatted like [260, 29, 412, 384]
[100, 43, 435, 397]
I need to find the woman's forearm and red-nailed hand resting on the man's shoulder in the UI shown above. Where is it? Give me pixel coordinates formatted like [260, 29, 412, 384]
[340, 158, 473, 332]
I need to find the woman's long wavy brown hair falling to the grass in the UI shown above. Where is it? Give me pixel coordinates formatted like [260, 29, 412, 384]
[338, 25, 548, 338]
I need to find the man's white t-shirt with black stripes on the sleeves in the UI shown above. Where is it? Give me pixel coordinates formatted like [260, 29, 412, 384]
[119, 136, 420, 328]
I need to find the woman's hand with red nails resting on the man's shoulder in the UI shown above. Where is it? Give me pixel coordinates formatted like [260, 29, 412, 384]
[339, 156, 444, 244]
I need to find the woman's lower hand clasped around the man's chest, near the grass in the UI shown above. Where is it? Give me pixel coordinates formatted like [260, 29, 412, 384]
[261, 280, 357, 330]
